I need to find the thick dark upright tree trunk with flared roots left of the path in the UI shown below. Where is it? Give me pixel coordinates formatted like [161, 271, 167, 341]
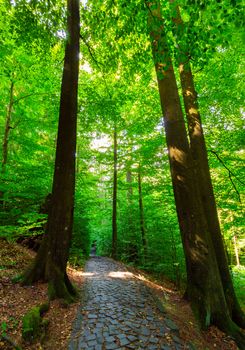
[23, 0, 80, 300]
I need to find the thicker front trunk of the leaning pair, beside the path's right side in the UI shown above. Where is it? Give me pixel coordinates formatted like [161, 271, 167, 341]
[148, 1, 245, 346]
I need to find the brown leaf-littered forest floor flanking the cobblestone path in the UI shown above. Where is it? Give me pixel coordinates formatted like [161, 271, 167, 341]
[0, 240, 240, 350]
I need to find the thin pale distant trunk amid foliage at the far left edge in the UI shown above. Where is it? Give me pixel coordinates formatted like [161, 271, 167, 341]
[2, 81, 14, 173]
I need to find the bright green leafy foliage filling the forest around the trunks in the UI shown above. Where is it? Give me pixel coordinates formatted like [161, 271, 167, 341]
[0, 0, 245, 293]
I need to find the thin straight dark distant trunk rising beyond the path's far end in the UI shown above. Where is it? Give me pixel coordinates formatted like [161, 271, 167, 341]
[112, 126, 117, 259]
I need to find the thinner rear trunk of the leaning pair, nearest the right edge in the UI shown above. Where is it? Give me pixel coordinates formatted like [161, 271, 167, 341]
[171, 0, 245, 328]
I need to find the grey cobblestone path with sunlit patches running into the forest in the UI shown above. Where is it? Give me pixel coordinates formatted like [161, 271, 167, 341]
[68, 257, 185, 350]
